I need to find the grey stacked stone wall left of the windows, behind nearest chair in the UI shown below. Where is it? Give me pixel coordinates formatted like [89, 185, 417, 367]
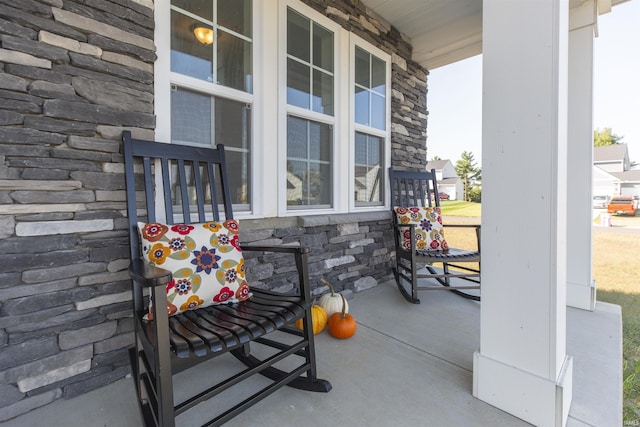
[0, 0, 155, 421]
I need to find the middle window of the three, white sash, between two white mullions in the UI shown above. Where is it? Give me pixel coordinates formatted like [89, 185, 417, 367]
[286, 8, 335, 209]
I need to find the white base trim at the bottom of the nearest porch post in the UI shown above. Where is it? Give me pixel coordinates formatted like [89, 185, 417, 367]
[473, 351, 573, 427]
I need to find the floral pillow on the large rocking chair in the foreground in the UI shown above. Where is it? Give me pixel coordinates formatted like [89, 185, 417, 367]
[138, 220, 251, 317]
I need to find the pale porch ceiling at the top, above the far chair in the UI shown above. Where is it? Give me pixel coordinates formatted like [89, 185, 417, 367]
[361, 0, 629, 70]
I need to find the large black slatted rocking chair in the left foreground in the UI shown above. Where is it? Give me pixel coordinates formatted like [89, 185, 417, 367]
[122, 131, 331, 427]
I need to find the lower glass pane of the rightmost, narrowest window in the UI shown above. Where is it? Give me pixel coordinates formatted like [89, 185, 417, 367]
[354, 132, 384, 206]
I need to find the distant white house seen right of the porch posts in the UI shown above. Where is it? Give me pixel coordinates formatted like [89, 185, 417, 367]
[593, 144, 640, 197]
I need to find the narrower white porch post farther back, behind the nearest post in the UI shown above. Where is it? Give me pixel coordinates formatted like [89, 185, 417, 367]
[567, 0, 596, 310]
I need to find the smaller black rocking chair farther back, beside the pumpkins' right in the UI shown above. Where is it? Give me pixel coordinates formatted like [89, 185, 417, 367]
[389, 168, 480, 304]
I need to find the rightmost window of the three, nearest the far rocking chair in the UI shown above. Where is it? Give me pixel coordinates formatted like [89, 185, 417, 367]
[353, 45, 388, 207]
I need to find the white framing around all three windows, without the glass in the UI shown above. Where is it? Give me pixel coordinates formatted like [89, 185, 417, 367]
[154, 0, 391, 219]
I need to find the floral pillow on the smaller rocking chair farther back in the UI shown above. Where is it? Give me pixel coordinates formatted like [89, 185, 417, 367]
[393, 206, 449, 252]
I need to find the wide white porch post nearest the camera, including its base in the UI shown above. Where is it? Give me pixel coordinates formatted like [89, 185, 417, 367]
[473, 0, 573, 426]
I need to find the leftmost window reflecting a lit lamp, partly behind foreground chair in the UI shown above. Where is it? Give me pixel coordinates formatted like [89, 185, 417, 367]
[170, 0, 253, 210]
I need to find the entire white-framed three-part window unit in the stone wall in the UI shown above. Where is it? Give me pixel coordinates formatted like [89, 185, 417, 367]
[154, 0, 391, 218]
